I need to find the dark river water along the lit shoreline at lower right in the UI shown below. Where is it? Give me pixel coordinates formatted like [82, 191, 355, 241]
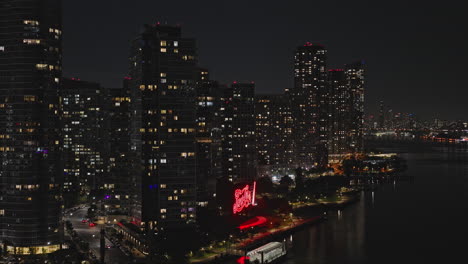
[282, 146, 468, 264]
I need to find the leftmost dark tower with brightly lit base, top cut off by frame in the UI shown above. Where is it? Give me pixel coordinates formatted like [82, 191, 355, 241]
[0, 0, 62, 254]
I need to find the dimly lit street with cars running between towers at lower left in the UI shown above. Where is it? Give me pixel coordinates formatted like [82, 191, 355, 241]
[65, 207, 131, 264]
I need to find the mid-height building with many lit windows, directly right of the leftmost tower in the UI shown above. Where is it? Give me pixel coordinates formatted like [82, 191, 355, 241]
[60, 78, 108, 207]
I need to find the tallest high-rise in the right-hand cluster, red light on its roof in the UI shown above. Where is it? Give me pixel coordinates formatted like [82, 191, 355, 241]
[291, 42, 329, 168]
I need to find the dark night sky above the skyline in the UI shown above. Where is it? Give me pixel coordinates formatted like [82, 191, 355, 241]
[63, 0, 468, 120]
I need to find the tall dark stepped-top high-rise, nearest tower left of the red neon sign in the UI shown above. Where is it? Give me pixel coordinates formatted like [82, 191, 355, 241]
[129, 24, 197, 230]
